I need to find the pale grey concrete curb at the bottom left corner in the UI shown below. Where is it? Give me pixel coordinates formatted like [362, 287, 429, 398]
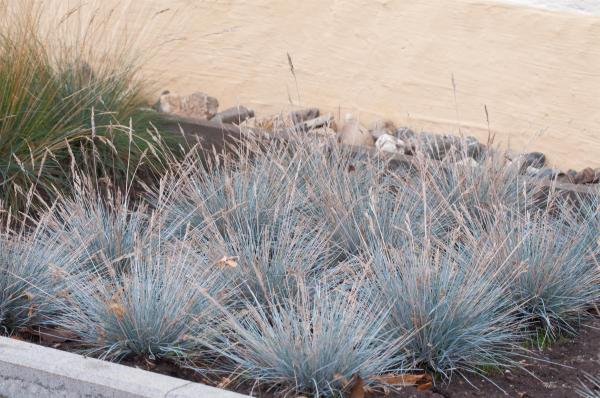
[0, 337, 247, 398]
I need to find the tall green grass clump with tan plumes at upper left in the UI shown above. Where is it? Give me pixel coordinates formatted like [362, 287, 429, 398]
[0, 3, 176, 213]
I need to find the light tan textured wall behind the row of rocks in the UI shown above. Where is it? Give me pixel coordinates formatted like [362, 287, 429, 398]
[44, 0, 600, 168]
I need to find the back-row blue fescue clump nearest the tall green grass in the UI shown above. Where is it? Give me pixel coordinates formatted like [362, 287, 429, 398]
[154, 145, 302, 239]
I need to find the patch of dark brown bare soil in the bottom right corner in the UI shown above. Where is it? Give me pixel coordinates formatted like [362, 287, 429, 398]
[390, 320, 600, 398]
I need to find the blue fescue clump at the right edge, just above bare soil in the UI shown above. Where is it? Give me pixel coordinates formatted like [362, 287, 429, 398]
[495, 213, 600, 338]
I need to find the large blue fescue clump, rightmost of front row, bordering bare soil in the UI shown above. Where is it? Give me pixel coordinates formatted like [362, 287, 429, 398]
[368, 233, 524, 379]
